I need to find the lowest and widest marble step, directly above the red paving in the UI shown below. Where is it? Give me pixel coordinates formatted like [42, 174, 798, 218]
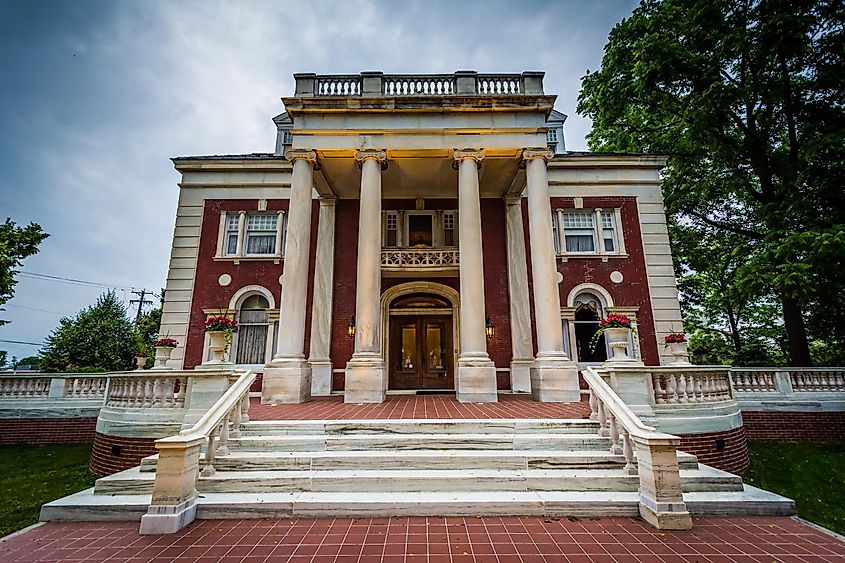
[41, 485, 795, 521]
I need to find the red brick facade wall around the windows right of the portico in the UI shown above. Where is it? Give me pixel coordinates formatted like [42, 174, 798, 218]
[544, 197, 660, 365]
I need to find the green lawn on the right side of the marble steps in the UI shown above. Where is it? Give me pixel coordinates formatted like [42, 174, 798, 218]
[743, 442, 845, 534]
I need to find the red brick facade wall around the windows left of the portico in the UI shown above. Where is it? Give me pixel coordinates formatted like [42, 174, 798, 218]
[184, 199, 320, 369]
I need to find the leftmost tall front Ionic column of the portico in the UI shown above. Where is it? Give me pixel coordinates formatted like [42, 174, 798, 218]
[261, 149, 317, 404]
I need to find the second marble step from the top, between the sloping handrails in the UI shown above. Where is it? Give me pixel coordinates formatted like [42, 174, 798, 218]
[229, 433, 610, 452]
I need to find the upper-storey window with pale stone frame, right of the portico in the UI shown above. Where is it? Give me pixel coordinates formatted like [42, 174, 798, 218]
[552, 209, 625, 254]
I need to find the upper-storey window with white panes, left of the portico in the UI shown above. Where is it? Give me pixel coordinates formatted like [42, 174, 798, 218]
[221, 212, 286, 257]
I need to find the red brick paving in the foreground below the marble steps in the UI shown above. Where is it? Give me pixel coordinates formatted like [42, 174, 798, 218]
[0, 517, 845, 563]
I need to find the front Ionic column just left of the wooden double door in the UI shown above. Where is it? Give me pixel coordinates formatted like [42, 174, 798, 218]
[344, 149, 387, 403]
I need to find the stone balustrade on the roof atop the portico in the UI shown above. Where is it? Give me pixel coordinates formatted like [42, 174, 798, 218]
[294, 70, 544, 98]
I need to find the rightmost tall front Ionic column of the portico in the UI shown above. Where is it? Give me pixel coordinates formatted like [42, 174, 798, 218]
[522, 148, 581, 402]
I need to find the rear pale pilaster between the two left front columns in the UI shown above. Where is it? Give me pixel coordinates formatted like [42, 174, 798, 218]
[308, 198, 335, 396]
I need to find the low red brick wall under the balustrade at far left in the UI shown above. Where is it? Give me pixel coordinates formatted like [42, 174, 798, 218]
[0, 417, 97, 444]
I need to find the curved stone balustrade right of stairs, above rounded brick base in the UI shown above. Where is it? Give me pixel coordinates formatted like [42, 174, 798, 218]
[651, 366, 733, 405]
